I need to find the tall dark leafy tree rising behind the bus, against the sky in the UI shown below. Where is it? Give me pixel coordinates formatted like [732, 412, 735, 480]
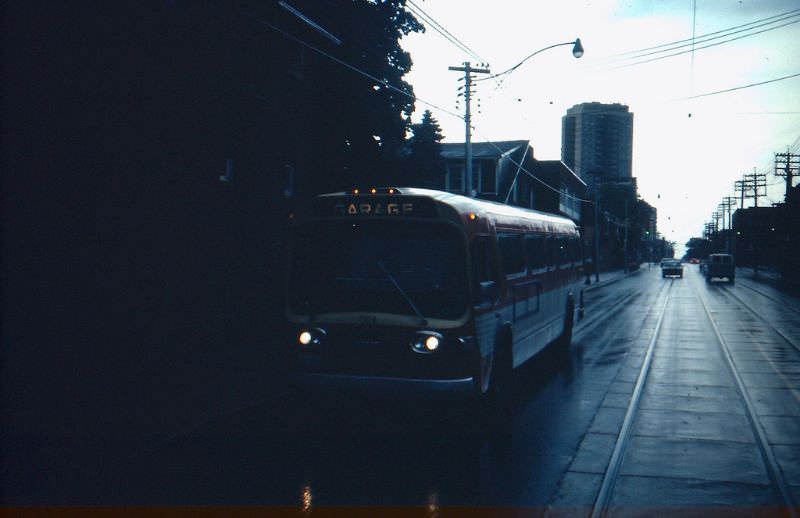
[299, 0, 423, 192]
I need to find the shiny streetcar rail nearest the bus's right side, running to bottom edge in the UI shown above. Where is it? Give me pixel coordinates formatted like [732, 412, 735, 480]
[591, 280, 675, 518]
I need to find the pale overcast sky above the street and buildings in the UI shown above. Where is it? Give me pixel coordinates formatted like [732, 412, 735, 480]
[402, 0, 800, 256]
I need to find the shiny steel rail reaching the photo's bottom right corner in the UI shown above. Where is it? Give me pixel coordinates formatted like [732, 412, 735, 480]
[697, 276, 797, 518]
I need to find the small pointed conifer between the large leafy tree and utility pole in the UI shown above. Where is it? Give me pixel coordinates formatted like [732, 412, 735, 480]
[401, 110, 445, 188]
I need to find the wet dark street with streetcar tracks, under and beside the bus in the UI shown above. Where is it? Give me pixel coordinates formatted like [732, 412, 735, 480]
[4, 265, 800, 515]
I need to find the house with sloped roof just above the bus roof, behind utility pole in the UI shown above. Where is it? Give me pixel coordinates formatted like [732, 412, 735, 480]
[437, 140, 587, 223]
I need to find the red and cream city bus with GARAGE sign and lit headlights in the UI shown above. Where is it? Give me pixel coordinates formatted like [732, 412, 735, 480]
[286, 188, 585, 397]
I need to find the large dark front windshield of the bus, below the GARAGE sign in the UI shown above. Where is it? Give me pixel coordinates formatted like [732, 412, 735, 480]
[289, 220, 469, 319]
